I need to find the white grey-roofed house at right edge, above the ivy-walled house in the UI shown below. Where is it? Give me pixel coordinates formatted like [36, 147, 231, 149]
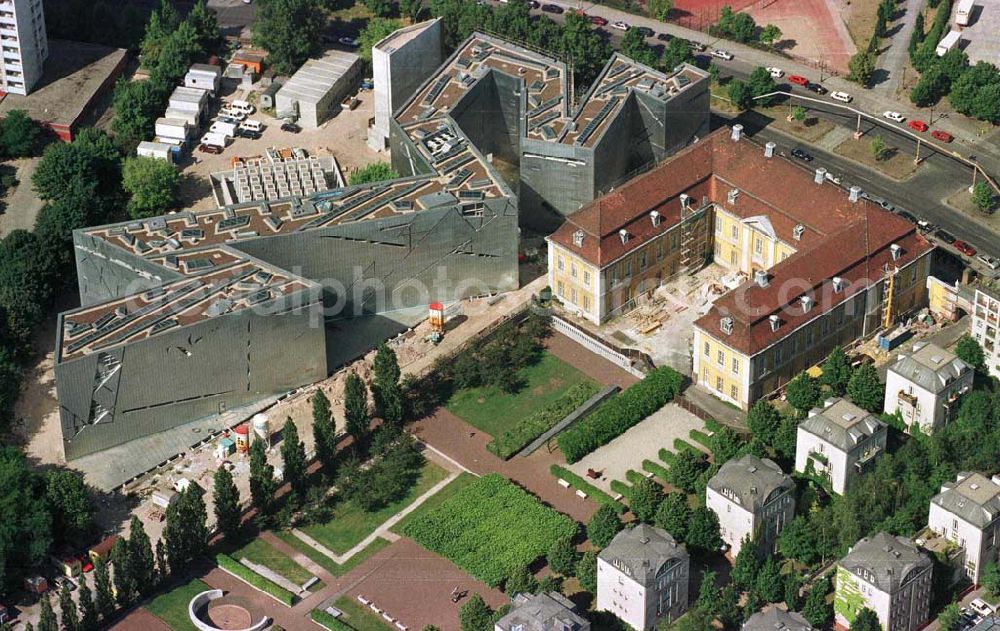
[927, 472, 1000, 583]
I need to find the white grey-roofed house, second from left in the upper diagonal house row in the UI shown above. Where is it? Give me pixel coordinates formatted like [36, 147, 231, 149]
[705, 454, 795, 558]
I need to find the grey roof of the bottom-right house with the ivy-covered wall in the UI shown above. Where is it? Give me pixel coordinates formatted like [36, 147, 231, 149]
[840, 532, 931, 594]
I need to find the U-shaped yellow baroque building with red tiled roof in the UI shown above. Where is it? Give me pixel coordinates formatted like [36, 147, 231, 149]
[548, 126, 933, 409]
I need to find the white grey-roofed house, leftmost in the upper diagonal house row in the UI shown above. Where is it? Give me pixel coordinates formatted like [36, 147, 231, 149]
[597, 524, 690, 631]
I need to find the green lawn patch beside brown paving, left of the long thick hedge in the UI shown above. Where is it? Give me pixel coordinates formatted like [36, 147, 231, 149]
[445, 353, 592, 436]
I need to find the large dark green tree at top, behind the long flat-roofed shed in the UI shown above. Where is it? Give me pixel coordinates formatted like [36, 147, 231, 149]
[251, 0, 327, 75]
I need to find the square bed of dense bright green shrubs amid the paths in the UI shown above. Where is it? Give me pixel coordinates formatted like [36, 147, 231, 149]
[403, 473, 577, 587]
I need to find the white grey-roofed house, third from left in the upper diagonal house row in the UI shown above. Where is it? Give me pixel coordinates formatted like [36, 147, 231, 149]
[795, 397, 888, 494]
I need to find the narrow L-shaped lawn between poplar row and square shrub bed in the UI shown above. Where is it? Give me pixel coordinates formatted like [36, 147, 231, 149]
[300, 462, 448, 554]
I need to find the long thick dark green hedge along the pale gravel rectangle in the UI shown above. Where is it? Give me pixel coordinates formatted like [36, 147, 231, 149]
[559, 366, 684, 464]
